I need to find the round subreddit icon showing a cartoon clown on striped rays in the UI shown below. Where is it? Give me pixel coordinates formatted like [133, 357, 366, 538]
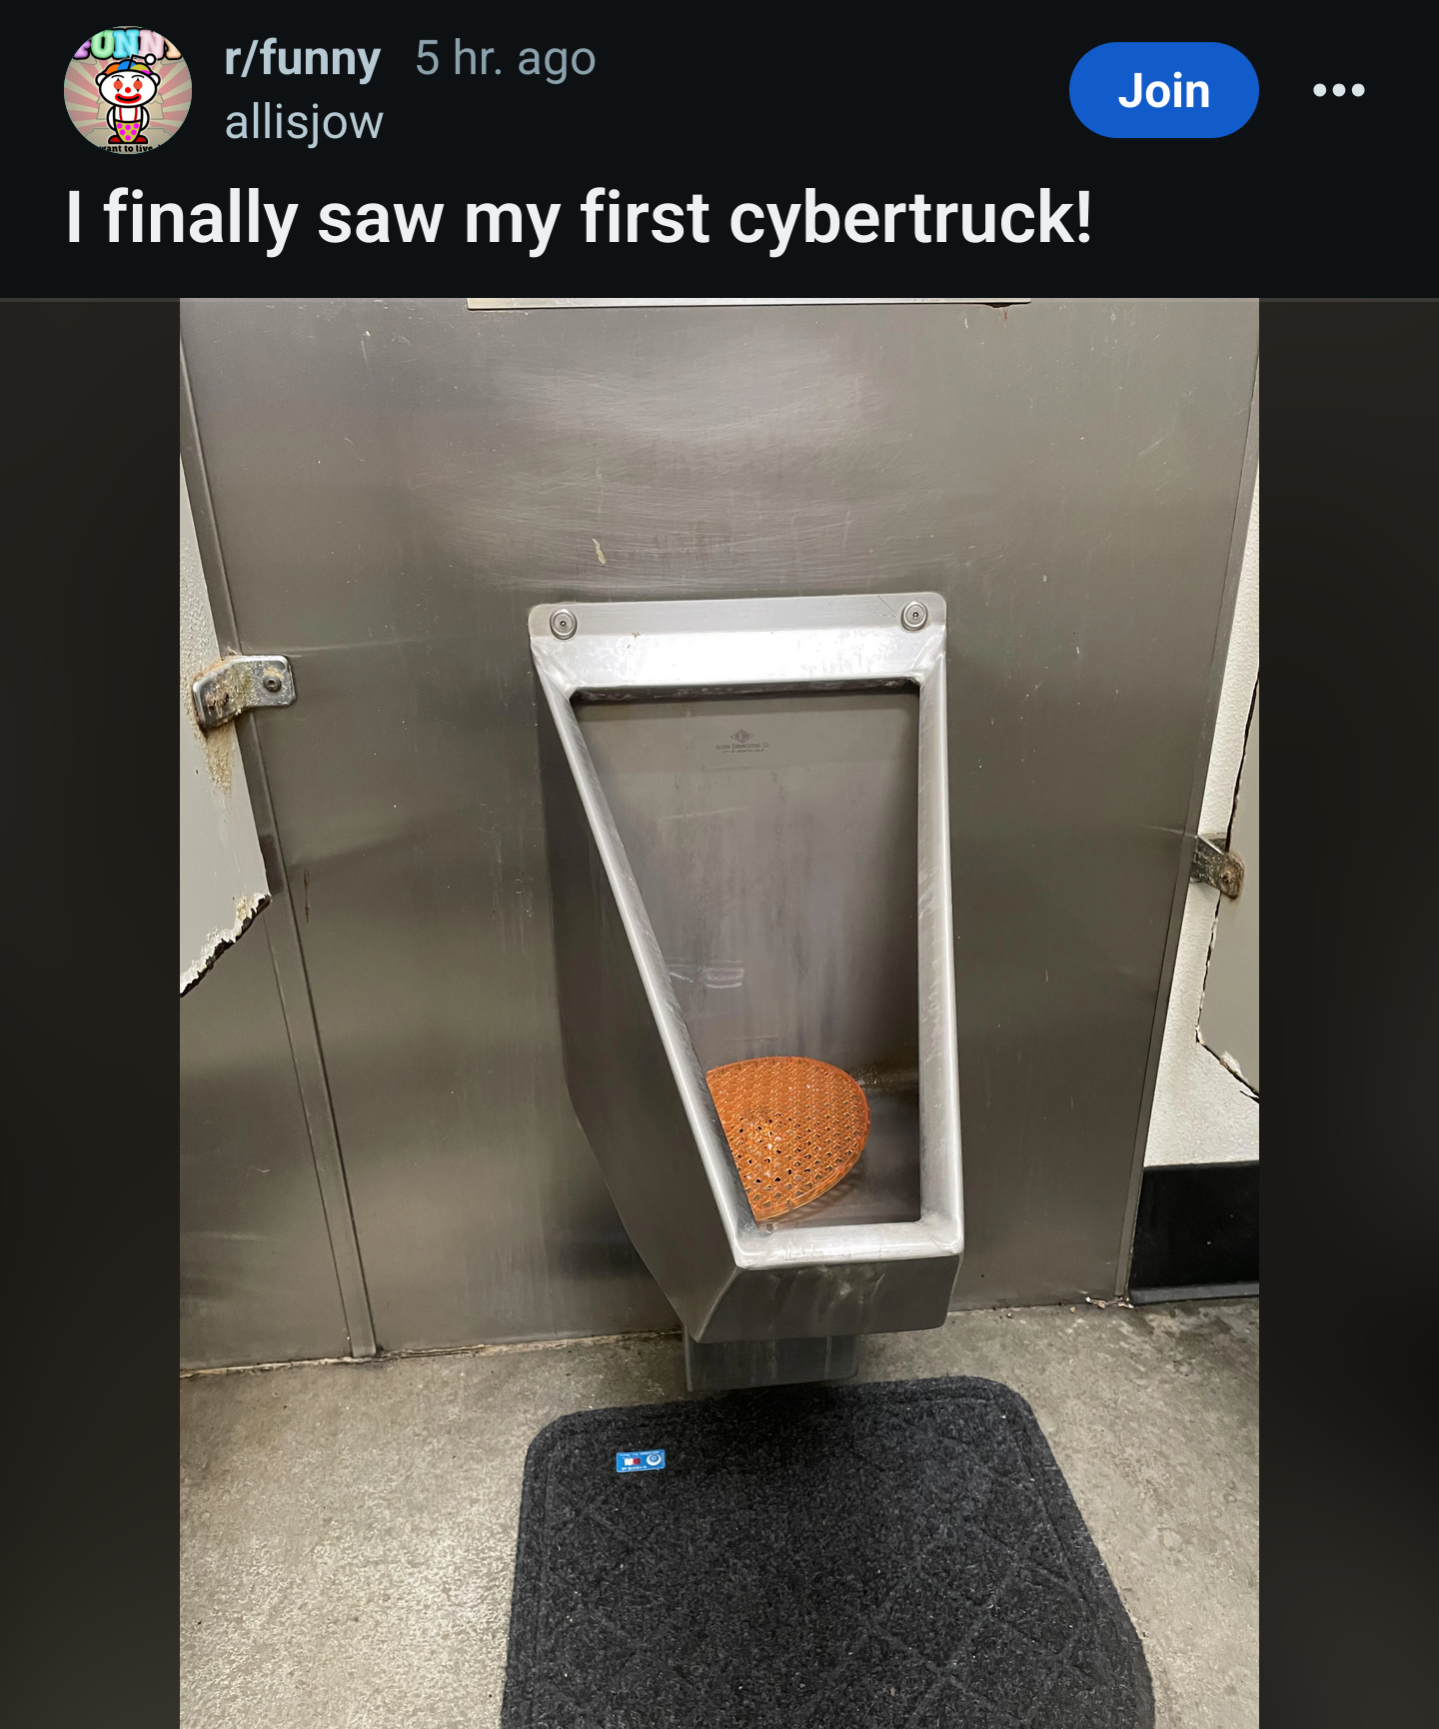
[66, 29, 190, 156]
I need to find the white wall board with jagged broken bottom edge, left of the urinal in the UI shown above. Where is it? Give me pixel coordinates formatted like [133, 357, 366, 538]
[180, 469, 270, 994]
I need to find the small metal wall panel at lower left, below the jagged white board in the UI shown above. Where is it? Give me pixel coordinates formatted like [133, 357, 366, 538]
[180, 909, 349, 1369]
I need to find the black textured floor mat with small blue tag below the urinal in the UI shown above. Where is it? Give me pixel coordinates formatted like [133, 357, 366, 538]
[503, 1378, 1154, 1729]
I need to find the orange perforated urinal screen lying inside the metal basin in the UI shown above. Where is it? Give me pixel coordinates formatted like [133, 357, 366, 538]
[704, 1056, 870, 1219]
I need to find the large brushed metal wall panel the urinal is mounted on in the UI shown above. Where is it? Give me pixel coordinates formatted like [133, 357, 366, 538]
[182, 299, 1257, 1347]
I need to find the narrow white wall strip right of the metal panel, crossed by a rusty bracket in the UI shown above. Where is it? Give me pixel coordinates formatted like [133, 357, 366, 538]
[1145, 481, 1259, 1165]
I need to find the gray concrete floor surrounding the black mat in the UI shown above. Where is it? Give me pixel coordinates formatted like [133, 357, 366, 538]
[182, 1300, 1259, 1729]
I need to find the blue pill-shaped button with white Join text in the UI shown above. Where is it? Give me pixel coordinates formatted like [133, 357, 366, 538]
[1069, 41, 1259, 138]
